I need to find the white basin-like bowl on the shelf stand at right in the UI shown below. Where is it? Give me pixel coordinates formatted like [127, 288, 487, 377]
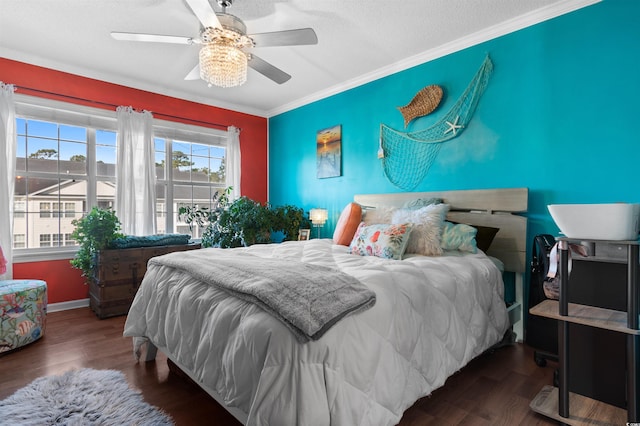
[547, 203, 640, 240]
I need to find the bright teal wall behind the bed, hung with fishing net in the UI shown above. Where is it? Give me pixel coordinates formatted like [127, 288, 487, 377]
[269, 0, 640, 240]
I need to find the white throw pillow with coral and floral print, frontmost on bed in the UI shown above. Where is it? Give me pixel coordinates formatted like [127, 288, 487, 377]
[349, 222, 411, 260]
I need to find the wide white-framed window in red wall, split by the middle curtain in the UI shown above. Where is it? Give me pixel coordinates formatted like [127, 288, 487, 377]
[14, 97, 228, 256]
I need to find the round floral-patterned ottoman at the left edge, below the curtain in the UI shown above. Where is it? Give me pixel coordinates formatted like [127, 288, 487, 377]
[0, 280, 47, 353]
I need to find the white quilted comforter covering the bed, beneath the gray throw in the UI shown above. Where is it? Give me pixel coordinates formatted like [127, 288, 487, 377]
[124, 240, 508, 426]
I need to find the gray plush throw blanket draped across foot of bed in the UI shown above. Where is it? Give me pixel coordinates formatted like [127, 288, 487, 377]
[149, 249, 376, 343]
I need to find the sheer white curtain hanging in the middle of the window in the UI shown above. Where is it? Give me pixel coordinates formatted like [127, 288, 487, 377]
[116, 106, 156, 236]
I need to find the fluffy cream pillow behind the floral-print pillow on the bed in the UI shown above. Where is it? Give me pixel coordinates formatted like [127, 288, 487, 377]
[391, 204, 449, 256]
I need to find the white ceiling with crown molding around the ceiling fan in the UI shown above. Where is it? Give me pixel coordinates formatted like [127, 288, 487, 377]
[0, 0, 599, 117]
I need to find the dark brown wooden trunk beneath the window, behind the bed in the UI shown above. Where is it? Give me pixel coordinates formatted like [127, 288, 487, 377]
[89, 244, 200, 319]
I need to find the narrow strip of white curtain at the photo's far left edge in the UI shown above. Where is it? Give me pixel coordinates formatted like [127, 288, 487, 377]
[0, 81, 16, 279]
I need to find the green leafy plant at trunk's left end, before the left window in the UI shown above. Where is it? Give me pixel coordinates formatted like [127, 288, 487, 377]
[71, 207, 124, 280]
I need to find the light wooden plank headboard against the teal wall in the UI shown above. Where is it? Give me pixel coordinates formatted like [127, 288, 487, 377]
[354, 188, 529, 273]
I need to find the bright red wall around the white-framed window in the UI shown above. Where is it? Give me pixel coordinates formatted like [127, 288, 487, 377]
[0, 58, 267, 303]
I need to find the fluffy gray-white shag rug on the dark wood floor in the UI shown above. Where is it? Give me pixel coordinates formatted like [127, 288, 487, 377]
[0, 368, 173, 426]
